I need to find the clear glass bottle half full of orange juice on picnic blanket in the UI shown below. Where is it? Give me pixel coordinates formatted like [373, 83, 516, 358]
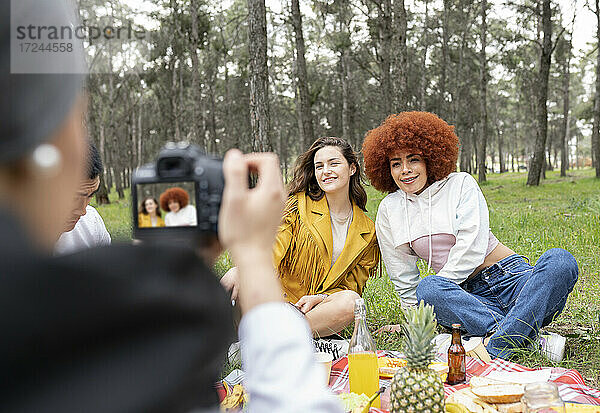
[348, 298, 381, 408]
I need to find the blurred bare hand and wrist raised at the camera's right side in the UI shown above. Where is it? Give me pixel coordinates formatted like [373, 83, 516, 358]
[219, 149, 285, 312]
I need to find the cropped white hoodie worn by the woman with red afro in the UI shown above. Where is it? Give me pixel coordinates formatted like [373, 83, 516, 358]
[375, 172, 490, 305]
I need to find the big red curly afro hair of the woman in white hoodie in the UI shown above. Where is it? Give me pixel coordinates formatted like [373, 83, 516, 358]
[362, 112, 459, 192]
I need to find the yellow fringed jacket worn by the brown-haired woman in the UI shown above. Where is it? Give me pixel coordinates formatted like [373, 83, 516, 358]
[273, 192, 380, 303]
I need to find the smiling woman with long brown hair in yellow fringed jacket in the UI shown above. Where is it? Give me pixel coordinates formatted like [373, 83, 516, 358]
[221, 138, 379, 336]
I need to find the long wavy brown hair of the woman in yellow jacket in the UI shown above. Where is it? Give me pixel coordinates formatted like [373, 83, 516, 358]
[288, 137, 367, 211]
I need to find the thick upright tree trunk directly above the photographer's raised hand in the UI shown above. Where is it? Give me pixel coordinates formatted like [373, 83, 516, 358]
[248, 0, 272, 152]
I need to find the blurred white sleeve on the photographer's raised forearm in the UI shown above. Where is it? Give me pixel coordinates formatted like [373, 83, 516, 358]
[240, 302, 342, 413]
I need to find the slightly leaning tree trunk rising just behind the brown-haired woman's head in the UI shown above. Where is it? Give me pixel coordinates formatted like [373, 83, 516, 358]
[291, 0, 315, 151]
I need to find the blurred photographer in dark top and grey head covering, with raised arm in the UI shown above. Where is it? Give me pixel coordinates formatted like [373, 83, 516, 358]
[0, 0, 340, 413]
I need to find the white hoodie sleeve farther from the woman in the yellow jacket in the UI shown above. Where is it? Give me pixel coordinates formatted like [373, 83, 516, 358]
[437, 175, 490, 284]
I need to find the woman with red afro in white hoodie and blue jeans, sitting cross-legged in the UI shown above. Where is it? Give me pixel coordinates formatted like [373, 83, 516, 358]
[363, 112, 579, 360]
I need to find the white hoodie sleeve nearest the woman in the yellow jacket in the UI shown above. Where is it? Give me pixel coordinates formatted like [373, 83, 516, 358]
[375, 200, 421, 306]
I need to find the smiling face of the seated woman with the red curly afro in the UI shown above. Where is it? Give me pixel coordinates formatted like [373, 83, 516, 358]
[390, 150, 429, 195]
